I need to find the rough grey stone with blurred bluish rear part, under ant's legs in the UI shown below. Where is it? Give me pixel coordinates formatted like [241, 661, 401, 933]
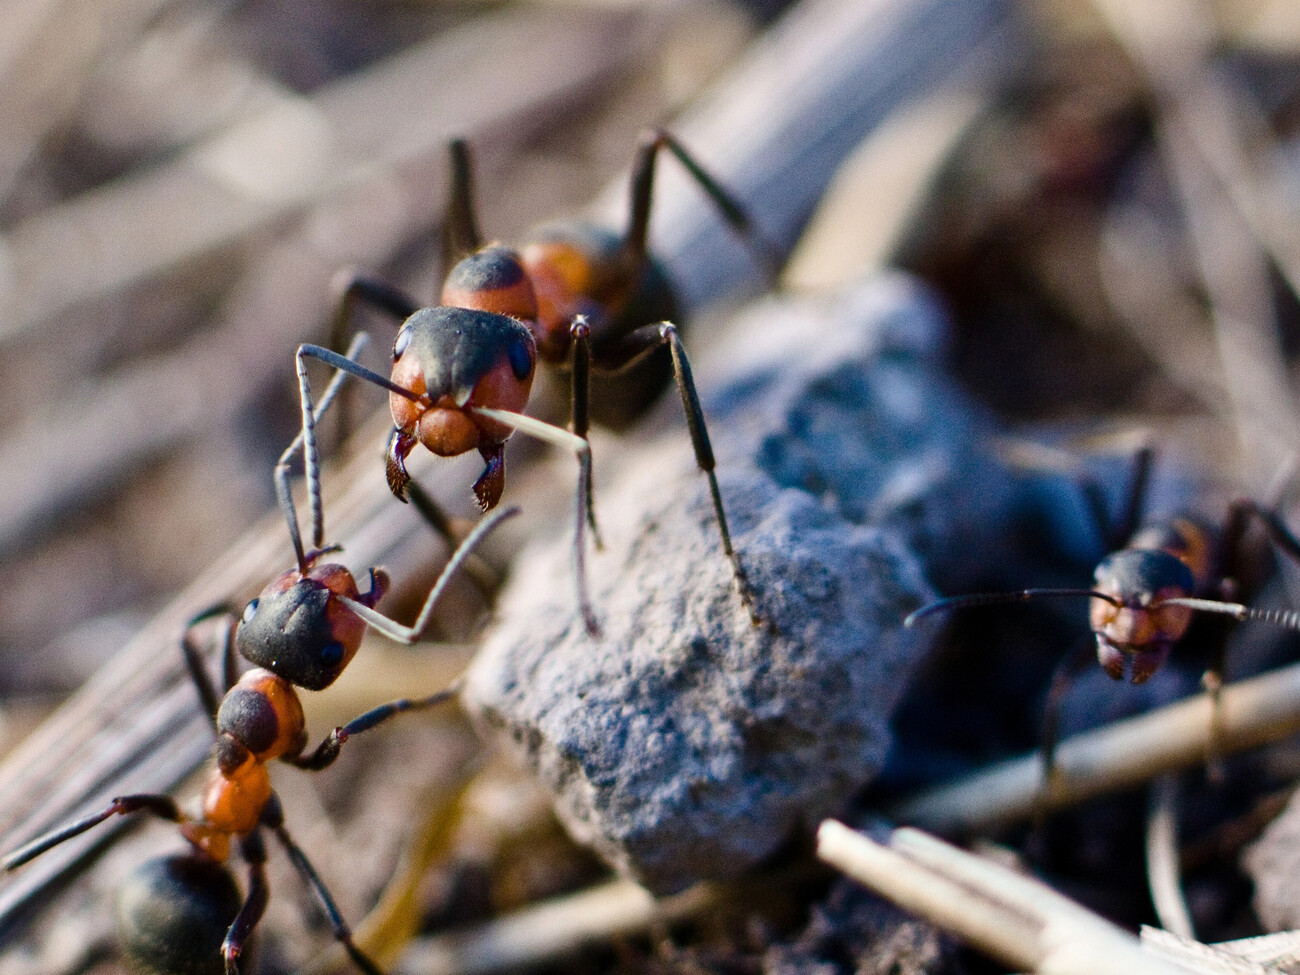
[464, 278, 1005, 892]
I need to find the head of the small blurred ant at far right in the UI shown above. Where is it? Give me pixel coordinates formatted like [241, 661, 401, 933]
[1088, 549, 1196, 684]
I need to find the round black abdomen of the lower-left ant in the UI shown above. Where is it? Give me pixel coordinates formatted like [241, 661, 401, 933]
[117, 853, 242, 975]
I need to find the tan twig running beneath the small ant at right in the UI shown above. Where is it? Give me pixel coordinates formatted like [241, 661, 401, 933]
[888, 664, 1300, 833]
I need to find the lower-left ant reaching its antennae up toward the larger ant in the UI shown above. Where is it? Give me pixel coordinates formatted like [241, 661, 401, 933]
[4, 335, 517, 975]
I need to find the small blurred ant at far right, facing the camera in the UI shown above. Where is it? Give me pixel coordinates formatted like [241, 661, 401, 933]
[904, 447, 1300, 784]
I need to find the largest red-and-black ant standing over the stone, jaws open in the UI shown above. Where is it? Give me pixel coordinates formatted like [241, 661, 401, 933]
[298, 131, 777, 634]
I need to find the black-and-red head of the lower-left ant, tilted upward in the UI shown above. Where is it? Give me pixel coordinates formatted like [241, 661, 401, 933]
[235, 554, 387, 690]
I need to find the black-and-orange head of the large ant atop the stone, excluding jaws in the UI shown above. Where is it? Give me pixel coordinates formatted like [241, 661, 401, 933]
[389, 307, 537, 456]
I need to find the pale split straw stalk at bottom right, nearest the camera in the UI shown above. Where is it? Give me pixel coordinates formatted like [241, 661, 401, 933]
[818, 819, 1188, 975]
